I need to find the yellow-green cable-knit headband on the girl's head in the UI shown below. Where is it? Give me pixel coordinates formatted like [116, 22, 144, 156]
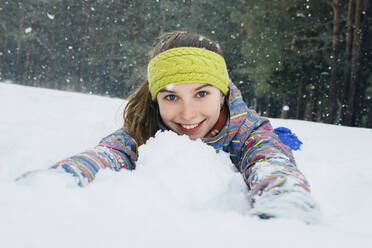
[147, 47, 229, 100]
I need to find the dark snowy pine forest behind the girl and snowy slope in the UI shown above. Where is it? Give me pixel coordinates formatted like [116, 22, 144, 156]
[0, 0, 372, 128]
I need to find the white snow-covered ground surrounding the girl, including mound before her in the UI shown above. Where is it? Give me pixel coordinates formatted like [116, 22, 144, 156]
[0, 83, 372, 248]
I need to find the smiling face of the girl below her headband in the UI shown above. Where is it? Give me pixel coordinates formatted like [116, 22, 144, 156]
[157, 83, 224, 140]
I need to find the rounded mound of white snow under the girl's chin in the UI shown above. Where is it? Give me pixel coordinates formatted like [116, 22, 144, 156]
[134, 131, 248, 212]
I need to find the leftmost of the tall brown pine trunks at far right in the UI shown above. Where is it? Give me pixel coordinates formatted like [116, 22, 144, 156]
[327, 0, 341, 123]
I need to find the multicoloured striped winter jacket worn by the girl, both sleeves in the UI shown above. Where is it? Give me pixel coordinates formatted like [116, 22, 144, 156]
[53, 83, 309, 206]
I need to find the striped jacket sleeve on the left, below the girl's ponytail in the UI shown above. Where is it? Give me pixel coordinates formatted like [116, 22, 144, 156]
[51, 129, 138, 186]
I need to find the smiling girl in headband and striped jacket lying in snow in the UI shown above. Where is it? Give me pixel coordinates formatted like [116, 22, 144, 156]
[21, 31, 315, 221]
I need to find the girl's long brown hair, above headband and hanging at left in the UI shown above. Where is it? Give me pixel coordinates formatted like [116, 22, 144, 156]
[123, 31, 222, 146]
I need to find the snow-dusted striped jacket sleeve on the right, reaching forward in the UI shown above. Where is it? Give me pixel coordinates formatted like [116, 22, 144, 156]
[238, 120, 310, 208]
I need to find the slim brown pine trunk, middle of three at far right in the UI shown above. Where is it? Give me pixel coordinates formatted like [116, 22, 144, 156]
[341, 0, 354, 125]
